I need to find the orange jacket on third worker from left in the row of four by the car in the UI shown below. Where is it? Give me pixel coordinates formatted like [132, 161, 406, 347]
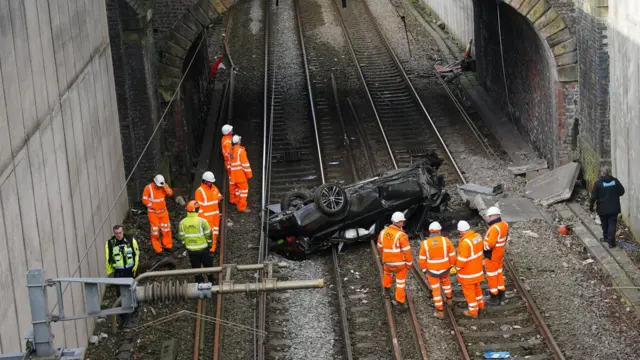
[456, 231, 484, 284]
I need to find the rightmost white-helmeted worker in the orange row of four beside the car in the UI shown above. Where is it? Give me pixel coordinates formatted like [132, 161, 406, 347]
[484, 206, 509, 305]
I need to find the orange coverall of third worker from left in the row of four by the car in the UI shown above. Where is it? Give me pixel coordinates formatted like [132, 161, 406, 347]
[456, 231, 484, 316]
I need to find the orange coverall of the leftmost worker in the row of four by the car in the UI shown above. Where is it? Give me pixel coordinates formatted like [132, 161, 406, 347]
[378, 225, 413, 304]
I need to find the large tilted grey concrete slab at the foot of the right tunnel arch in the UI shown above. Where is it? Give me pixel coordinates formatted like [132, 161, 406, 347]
[525, 162, 580, 206]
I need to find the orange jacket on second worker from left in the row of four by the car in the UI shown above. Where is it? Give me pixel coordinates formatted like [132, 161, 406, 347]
[418, 235, 456, 275]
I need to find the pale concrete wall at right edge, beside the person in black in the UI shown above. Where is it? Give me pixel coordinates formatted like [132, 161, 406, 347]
[608, 0, 640, 238]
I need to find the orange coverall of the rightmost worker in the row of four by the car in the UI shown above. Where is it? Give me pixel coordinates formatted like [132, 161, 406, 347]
[484, 218, 509, 295]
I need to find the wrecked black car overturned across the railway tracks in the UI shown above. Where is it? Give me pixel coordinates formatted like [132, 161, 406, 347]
[267, 153, 450, 259]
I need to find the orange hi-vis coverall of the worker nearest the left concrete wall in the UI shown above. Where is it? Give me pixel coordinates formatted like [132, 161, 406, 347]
[142, 183, 173, 254]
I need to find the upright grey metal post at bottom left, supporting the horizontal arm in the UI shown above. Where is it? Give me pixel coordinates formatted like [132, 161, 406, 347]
[27, 269, 55, 357]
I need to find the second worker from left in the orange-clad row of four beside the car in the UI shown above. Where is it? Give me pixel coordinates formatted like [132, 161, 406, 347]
[418, 222, 456, 319]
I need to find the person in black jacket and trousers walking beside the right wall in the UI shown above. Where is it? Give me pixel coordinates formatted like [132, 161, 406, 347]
[589, 166, 624, 248]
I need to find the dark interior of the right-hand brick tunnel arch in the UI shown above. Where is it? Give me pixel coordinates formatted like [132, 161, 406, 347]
[474, 0, 557, 160]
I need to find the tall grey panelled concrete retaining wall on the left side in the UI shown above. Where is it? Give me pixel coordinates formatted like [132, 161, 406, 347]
[0, 0, 127, 353]
